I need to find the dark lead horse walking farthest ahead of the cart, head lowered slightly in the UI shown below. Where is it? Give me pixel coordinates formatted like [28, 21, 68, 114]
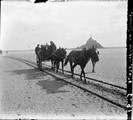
[64, 47, 99, 83]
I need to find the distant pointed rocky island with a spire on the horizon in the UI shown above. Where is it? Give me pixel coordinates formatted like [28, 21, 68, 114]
[77, 37, 103, 49]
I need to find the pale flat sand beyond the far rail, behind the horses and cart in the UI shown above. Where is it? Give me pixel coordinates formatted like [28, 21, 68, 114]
[6, 48, 126, 88]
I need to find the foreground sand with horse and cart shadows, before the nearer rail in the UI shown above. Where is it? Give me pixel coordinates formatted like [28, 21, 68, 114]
[0, 56, 126, 119]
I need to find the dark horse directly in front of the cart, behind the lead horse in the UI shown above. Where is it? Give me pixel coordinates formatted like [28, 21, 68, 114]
[53, 48, 67, 73]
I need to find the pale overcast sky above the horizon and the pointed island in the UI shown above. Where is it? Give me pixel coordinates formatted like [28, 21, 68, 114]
[0, 1, 127, 50]
